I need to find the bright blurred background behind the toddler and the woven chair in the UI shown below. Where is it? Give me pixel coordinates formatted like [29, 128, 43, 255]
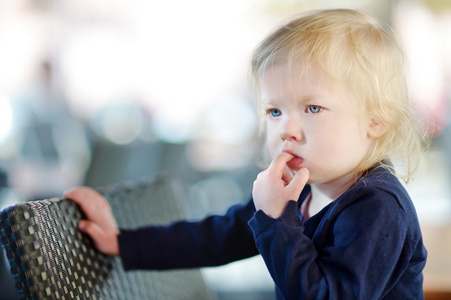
[0, 0, 451, 299]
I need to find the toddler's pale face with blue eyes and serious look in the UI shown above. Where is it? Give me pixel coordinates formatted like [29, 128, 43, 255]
[261, 64, 372, 190]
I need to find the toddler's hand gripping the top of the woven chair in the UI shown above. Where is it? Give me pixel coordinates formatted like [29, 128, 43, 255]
[64, 187, 119, 256]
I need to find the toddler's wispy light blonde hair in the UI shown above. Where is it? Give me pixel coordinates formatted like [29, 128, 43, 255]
[251, 9, 430, 182]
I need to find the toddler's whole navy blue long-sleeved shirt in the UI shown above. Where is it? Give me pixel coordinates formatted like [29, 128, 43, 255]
[119, 168, 427, 299]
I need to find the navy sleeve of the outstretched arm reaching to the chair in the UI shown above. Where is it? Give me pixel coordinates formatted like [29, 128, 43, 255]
[119, 200, 258, 270]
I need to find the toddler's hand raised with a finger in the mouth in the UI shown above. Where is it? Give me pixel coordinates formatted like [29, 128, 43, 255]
[252, 152, 309, 219]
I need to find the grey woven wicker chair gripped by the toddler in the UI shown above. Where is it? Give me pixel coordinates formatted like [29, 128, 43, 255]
[0, 176, 213, 300]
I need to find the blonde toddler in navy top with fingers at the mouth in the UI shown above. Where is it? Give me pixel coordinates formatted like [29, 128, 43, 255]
[66, 9, 426, 299]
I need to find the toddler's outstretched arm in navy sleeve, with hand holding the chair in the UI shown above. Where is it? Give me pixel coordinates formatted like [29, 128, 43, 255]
[65, 187, 258, 269]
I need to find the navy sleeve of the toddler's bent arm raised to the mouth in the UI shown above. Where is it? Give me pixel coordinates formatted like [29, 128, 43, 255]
[250, 179, 426, 299]
